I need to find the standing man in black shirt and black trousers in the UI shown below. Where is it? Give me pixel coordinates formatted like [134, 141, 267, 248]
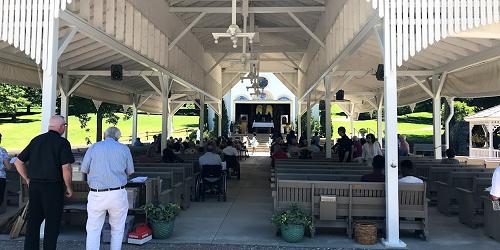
[14, 115, 75, 250]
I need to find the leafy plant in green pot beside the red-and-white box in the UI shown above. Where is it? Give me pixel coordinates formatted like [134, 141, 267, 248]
[143, 203, 181, 239]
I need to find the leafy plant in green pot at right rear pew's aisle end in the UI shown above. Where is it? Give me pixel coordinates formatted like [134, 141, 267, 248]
[272, 205, 314, 243]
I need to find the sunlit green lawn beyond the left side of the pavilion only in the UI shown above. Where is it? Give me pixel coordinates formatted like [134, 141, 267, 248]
[0, 114, 199, 151]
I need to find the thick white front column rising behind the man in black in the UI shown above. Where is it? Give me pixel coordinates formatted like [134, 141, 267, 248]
[41, 9, 59, 133]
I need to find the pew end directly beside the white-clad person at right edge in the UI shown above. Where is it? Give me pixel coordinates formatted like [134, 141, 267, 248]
[456, 177, 491, 228]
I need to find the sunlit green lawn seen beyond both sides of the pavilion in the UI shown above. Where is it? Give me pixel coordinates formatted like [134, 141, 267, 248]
[0, 105, 432, 151]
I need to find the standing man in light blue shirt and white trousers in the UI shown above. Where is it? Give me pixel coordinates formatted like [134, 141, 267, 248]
[81, 127, 134, 250]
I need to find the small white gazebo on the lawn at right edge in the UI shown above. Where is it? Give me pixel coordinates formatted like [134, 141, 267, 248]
[465, 105, 500, 158]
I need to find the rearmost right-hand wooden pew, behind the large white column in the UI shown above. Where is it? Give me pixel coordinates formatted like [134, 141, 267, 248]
[273, 179, 428, 237]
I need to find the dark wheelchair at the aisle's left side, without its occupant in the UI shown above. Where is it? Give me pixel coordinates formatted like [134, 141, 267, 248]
[196, 165, 227, 201]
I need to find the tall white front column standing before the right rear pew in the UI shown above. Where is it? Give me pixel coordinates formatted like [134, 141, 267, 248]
[382, 0, 406, 248]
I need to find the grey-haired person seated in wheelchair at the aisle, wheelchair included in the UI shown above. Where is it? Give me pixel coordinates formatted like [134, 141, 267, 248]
[199, 142, 226, 201]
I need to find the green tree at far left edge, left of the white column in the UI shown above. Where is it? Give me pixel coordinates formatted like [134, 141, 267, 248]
[0, 83, 30, 120]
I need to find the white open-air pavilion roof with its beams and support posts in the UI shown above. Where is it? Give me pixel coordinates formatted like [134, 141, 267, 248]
[0, 0, 500, 247]
